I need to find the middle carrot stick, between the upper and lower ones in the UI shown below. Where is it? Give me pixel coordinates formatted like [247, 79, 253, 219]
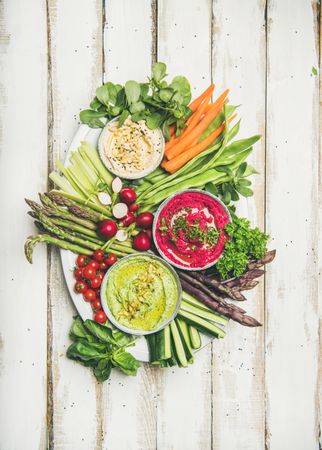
[166, 89, 228, 159]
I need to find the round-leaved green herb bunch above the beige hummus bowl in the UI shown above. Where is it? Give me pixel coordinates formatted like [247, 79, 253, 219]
[80, 62, 191, 139]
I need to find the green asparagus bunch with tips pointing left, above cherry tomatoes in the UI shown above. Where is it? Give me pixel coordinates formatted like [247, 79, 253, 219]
[25, 191, 135, 263]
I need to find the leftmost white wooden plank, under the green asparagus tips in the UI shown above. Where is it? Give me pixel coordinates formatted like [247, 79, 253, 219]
[0, 0, 47, 450]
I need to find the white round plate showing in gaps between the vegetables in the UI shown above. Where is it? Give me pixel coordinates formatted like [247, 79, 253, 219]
[60, 124, 212, 362]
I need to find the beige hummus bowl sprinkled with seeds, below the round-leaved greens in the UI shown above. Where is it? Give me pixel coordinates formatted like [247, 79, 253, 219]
[99, 117, 164, 179]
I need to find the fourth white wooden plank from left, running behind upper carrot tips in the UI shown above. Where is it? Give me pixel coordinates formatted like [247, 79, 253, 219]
[157, 0, 217, 450]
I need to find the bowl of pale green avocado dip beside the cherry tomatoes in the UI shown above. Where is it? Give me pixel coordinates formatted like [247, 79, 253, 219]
[106, 255, 180, 331]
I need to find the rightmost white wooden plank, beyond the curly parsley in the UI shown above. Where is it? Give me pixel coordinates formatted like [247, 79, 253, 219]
[266, 0, 320, 450]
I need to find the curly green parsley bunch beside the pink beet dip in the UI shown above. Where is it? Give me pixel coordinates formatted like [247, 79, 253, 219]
[216, 217, 269, 279]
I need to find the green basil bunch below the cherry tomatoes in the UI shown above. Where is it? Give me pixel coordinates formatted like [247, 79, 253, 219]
[67, 317, 140, 381]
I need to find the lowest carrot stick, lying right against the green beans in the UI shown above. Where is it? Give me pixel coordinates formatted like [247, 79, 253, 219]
[162, 114, 236, 173]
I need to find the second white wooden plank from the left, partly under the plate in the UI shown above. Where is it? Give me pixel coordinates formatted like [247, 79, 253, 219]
[48, 0, 102, 450]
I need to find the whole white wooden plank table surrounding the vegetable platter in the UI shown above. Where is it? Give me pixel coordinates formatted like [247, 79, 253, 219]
[0, 0, 321, 450]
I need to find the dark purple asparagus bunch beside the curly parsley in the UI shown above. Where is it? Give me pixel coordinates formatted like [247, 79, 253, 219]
[177, 250, 276, 327]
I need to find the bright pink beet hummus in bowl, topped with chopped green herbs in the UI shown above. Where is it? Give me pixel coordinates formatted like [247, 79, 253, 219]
[154, 190, 231, 269]
